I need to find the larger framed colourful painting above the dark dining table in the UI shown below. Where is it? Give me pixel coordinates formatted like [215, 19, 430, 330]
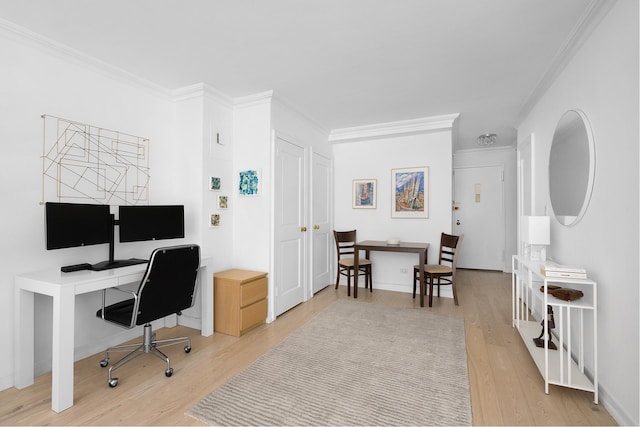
[391, 166, 429, 218]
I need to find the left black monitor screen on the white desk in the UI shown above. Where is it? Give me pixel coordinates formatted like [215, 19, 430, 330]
[45, 202, 113, 249]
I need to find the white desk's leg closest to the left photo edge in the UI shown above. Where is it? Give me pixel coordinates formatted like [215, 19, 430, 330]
[13, 286, 35, 389]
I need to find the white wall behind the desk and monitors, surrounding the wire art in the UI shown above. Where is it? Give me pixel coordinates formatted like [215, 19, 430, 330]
[0, 22, 205, 389]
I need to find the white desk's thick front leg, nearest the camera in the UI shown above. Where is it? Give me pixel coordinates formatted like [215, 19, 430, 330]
[51, 287, 76, 412]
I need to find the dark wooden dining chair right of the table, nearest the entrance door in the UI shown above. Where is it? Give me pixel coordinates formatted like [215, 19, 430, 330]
[413, 233, 464, 307]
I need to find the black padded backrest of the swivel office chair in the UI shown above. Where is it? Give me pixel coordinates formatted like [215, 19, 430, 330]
[134, 245, 200, 325]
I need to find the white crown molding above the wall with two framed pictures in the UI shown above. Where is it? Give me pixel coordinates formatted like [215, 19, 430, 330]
[329, 113, 460, 143]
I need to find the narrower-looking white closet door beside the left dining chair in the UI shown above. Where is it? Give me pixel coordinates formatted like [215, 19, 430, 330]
[311, 153, 333, 294]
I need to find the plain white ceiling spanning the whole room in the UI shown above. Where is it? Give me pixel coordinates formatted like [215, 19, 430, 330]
[0, 0, 595, 149]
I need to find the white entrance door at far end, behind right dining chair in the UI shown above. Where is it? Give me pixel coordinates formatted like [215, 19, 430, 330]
[453, 166, 504, 271]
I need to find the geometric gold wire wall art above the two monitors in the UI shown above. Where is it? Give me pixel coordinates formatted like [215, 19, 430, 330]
[42, 114, 151, 205]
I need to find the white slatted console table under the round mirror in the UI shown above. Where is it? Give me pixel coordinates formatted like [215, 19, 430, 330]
[511, 255, 598, 404]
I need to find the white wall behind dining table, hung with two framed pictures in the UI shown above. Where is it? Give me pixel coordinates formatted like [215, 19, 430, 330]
[333, 129, 453, 295]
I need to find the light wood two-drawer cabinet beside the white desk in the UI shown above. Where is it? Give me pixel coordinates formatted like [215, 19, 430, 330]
[213, 269, 267, 337]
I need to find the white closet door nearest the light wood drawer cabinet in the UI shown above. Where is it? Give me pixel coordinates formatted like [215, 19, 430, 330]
[274, 137, 307, 316]
